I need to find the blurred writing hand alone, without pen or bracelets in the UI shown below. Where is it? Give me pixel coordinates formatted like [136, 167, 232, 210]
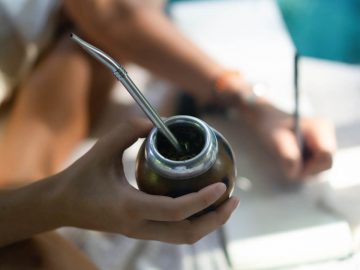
[243, 102, 336, 179]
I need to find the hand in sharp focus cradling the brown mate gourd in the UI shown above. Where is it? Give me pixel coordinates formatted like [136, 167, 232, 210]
[59, 119, 239, 244]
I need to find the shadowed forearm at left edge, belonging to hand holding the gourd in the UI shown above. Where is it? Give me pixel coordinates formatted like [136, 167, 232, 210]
[0, 176, 63, 247]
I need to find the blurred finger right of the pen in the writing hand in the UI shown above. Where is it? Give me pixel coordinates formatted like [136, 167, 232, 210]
[302, 121, 336, 176]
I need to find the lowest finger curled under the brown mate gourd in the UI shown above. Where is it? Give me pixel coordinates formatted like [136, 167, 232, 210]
[136, 197, 239, 244]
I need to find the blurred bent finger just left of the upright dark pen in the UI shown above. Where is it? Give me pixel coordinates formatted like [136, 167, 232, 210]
[272, 129, 301, 178]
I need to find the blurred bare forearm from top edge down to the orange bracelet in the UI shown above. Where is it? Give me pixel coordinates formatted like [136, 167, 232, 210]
[65, 1, 223, 102]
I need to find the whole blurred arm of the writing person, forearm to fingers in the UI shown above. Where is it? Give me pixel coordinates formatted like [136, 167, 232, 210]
[65, 0, 336, 178]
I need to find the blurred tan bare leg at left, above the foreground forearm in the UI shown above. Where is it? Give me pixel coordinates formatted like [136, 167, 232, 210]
[0, 34, 112, 187]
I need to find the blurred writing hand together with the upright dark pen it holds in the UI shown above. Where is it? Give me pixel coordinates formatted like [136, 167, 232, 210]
[219, 52, 336, 181]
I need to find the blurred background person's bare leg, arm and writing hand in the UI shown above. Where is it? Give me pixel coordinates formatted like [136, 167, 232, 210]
[0, 0, 335, 268]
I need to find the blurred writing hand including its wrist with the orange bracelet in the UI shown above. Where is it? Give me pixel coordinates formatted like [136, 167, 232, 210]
[216, 73, 336, 179]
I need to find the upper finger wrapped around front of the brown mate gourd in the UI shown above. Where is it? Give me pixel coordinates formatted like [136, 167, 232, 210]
[130, 183, 226, 221]
